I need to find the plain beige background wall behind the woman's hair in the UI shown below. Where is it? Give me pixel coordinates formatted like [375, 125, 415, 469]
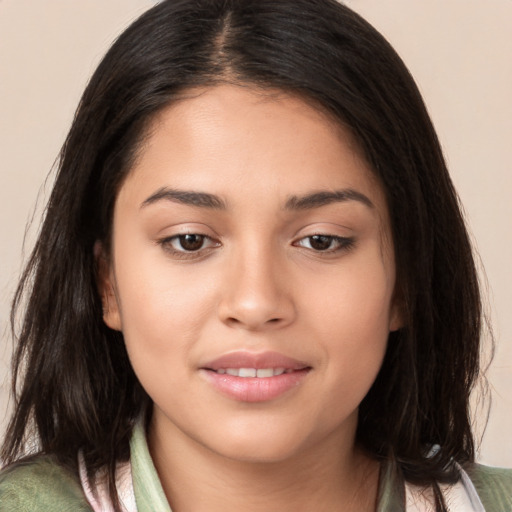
[0, 0, 512, 467]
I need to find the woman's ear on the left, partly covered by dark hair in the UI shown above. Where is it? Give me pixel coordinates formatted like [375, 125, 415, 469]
[94, 240, 122, 331]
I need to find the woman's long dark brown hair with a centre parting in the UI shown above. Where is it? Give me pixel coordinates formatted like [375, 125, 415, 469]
[1, 0, 481, 510]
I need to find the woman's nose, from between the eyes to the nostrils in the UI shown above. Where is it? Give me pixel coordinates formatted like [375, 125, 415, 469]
[219, 247, 296, 331]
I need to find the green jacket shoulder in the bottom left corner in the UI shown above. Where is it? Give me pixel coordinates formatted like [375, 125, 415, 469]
[0, 455, 92, 512]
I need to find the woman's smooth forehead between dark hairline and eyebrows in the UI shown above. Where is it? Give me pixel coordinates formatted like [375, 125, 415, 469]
[121, 85, 385, 214]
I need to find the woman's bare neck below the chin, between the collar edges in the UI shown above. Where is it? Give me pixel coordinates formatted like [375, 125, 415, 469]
[148, 418, 379, 512]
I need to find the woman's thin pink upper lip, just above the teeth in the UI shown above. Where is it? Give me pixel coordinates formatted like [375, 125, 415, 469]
[201, 351, 309, 371]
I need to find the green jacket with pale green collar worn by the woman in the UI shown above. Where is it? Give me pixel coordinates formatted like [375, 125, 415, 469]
[0, 428, 512, 512]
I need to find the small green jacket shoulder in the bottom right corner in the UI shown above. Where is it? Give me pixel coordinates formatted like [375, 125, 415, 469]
[464, 464, 512, 512]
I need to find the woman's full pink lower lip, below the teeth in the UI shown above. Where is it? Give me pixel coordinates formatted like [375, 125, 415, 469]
[201, 368, 309, 402]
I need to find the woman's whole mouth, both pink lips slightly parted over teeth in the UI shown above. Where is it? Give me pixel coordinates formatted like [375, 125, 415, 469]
[200, 352, 311, 402]
